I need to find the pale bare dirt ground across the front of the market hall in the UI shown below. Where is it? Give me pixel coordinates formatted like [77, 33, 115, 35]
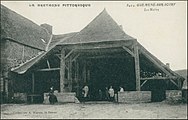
[1, 102, 187, 119]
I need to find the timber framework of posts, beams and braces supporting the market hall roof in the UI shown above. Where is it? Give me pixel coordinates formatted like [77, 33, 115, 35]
[56, 40, 181, 92]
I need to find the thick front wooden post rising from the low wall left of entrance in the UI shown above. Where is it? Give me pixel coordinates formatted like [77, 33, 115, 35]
[60, 49, 65, 92]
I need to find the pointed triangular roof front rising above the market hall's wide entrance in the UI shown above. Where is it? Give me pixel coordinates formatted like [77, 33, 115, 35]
[64, 9, 134, 44]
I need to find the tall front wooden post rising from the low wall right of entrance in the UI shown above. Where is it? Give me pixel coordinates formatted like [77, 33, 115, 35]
[134, 42, 140, 91]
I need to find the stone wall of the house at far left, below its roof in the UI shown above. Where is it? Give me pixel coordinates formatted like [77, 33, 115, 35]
[1, 39, 41, 102]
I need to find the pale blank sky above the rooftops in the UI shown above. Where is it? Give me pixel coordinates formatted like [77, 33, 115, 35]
[1, 1, 187, 70]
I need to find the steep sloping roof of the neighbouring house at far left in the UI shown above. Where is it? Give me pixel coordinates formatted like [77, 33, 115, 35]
[1, 5, 50, 50]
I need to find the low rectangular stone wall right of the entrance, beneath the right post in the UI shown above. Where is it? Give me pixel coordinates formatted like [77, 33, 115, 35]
[118, 91, 151, 103]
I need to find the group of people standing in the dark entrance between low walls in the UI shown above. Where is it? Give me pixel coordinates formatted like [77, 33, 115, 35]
[82, 85, 124, 101]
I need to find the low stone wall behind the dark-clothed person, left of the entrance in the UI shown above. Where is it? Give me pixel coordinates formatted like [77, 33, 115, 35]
[43, 92, 79, 104]
